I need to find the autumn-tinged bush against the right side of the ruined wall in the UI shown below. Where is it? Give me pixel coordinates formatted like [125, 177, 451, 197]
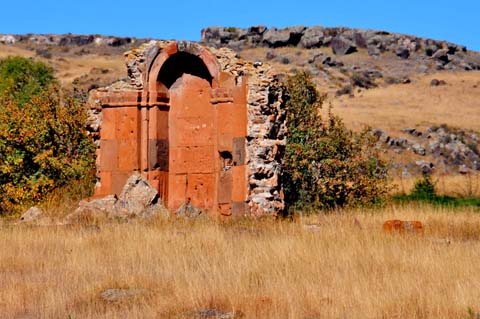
[282, 73, 389, 211]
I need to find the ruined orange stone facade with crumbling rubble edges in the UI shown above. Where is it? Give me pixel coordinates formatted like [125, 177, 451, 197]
[90, 41, 285, 216]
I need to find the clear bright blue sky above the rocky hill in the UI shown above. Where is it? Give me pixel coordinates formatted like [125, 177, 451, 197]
[0, 0, 480, 51]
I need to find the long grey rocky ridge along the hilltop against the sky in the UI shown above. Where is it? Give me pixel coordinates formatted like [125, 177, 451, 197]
[201, 26, 480, 70]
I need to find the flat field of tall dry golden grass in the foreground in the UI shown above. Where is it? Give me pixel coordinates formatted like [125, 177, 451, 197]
[0, 205, 480, 318]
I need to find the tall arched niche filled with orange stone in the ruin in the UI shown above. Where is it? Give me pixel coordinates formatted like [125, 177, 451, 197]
[144, 42, 219, 211]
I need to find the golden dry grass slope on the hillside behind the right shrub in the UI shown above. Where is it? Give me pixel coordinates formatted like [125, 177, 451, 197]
[332, 72, 480, 133]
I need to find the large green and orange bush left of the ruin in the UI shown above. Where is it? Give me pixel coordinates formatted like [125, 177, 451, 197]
[0, 58, 95, 214]
